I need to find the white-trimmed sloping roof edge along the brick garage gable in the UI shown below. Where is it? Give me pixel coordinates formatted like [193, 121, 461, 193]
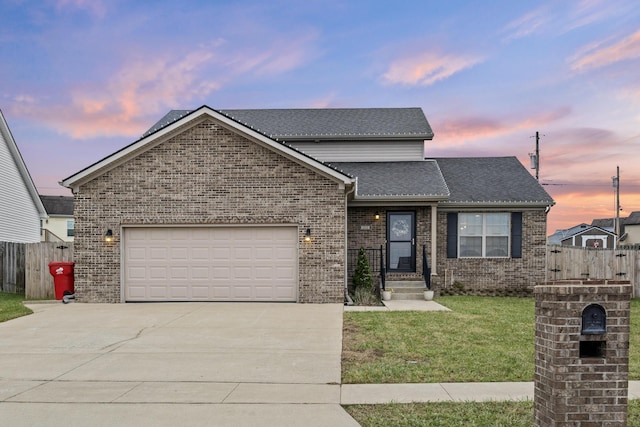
[61, 106, 353, 189]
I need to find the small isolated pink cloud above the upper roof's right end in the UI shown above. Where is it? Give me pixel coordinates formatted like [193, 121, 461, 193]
[383, 52, 482, 86]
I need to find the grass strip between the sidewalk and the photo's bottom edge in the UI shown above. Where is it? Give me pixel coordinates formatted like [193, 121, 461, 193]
[345, 400, 640, 427]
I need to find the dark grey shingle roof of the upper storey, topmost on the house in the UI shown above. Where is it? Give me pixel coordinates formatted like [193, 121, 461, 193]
[144, 108, 433, 141]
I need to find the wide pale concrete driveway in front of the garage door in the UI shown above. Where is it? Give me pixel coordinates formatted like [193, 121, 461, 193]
[0, 303, 358, 427]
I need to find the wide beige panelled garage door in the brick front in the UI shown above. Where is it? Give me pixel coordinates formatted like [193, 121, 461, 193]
[124, 227, 298, 301]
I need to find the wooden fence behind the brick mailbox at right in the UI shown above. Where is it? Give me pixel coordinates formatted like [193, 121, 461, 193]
[546, 245, 640, 298]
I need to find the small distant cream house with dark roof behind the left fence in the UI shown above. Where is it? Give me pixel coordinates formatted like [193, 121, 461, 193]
[40, 196, 75, 242]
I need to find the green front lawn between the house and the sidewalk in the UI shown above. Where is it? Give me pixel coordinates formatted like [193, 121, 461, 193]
[342, 297, 535, 384]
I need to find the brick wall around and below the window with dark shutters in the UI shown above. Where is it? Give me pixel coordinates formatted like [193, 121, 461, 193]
[433, 209, 547, 296]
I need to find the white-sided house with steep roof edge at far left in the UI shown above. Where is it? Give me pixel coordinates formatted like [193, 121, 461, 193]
[0, 111, 47, 243]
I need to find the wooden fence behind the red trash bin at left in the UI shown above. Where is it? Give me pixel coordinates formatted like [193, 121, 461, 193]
[0, 242, 73, 299]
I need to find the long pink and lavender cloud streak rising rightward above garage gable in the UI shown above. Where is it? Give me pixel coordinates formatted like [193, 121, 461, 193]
[10, 30, 314, 139]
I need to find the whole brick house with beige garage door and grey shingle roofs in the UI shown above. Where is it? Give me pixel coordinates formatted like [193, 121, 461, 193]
[62, 106, 554, 303]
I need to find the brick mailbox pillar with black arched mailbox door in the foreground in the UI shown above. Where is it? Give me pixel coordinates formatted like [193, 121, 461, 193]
[534, 280, 632, 427]
